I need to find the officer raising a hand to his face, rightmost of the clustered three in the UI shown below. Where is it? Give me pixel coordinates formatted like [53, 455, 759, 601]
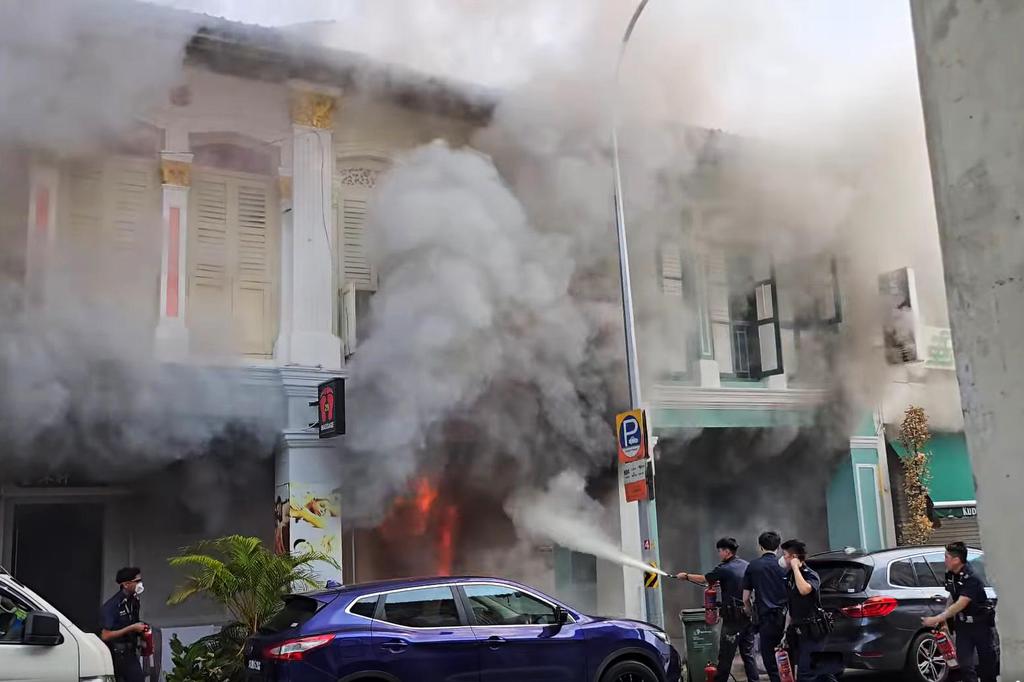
[782, 540, 843, 682]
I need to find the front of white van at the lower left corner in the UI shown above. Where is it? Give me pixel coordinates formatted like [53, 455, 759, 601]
[0, 567, 114, 682]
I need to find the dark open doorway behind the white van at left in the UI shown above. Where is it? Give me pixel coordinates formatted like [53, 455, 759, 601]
[11, 503, 103, 633]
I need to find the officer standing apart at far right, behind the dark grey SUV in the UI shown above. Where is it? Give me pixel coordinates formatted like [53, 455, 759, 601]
[922, 543, 999, 682]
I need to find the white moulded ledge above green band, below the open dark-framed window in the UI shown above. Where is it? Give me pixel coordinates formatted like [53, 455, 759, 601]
[649, 384, 828, 410]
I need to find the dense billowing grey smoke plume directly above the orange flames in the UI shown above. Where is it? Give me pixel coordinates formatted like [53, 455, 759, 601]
[346, 142, 611, 518]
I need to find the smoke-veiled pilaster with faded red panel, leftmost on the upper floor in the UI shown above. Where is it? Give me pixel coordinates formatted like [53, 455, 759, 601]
[25, 160, 60, 298]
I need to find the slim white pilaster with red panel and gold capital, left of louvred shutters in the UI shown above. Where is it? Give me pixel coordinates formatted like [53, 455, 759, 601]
[156, 152, 193, 359]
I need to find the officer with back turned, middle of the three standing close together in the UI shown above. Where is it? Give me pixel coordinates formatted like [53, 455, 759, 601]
[743, 530, 787, 682]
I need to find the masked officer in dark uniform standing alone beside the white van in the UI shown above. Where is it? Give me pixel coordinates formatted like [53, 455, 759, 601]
[99, 566, 148, 682]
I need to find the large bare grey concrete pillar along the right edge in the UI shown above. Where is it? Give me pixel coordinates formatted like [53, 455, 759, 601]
[910, 0, 1024, 663]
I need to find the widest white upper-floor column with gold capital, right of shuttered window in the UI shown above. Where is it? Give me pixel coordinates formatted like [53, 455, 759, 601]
[282, 85, 341, 369]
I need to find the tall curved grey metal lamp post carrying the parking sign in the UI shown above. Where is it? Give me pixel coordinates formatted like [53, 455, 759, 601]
[611, 0, 665, 628]
